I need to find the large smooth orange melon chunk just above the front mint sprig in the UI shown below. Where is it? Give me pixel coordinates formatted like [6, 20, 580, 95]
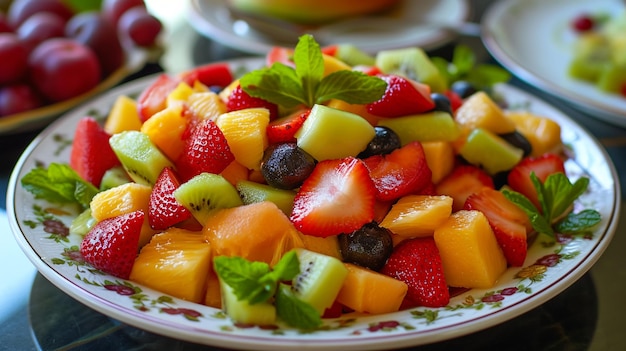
[202, 201, 304, 266]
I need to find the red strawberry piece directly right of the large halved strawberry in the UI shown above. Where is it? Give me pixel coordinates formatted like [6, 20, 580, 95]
[363, 141, 432, 201]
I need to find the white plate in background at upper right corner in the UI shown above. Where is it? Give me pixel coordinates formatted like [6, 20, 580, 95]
[482, 0, 626, 127]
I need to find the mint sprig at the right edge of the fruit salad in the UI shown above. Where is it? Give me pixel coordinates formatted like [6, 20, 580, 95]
[503, 172, 601, 237]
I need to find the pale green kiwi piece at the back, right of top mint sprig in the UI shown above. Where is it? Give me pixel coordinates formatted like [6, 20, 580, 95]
[376, 47, 448, 93]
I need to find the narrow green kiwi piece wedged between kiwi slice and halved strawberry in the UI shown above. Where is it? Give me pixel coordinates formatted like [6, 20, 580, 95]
[237, 180, 296, 216]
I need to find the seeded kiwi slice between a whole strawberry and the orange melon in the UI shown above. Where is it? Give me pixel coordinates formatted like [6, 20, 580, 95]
[174, 173, 243, 225]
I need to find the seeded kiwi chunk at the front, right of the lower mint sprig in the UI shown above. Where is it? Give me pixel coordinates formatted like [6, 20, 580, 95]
[291, 248, 348, 315]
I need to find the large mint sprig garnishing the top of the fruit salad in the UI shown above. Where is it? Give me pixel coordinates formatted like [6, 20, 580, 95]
[239, 34, 387, 108]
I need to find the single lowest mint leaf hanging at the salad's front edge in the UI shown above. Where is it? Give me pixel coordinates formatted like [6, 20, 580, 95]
[276, 284, 322, 330]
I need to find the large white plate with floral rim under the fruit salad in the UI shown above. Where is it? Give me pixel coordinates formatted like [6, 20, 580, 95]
[7, 60, 620, 350]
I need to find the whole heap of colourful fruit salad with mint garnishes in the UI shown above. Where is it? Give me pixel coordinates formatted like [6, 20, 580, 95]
[21, 35, 600, 330]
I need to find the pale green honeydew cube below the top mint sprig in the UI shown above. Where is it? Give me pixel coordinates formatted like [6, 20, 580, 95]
[295, 105, 376, 161]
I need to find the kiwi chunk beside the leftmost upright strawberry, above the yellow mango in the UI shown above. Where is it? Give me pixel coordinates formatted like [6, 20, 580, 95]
[109, 130, 174, 186]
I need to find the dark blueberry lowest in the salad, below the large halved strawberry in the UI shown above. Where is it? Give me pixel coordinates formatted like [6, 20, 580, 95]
[338, 222, 393, 271]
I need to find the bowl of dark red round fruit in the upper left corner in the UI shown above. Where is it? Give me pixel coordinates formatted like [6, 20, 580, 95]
[0, 0, 163, 134]
